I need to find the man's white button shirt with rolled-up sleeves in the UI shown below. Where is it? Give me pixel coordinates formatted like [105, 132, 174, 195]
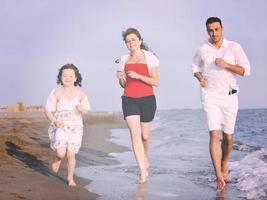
[192, 39, 250, 96]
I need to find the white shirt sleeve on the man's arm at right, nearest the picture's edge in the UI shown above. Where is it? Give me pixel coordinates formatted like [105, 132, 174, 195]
[234, 43, 250, 76]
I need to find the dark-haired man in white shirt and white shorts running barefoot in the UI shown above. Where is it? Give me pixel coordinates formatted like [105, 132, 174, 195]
[192, 17, 250, 189]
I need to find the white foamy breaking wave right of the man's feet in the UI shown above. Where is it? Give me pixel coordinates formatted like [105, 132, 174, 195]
[229, 149, 267, 200]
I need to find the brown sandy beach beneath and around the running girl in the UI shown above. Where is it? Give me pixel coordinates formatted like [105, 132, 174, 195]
[0, 112, 126, 200]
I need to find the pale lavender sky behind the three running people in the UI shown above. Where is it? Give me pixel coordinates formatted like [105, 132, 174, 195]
[0, 0, 267, 111]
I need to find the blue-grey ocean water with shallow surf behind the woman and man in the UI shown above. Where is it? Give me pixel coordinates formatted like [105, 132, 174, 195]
[75, 109, 267, 200]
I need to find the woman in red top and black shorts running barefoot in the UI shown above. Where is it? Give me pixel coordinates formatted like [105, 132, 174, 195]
[117, 28, 159, 184]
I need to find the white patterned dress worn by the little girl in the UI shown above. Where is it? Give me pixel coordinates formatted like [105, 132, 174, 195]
[46, 89, 91, 153]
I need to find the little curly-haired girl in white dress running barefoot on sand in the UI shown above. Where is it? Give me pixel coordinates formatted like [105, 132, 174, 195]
[45, 64, 91, 186]
